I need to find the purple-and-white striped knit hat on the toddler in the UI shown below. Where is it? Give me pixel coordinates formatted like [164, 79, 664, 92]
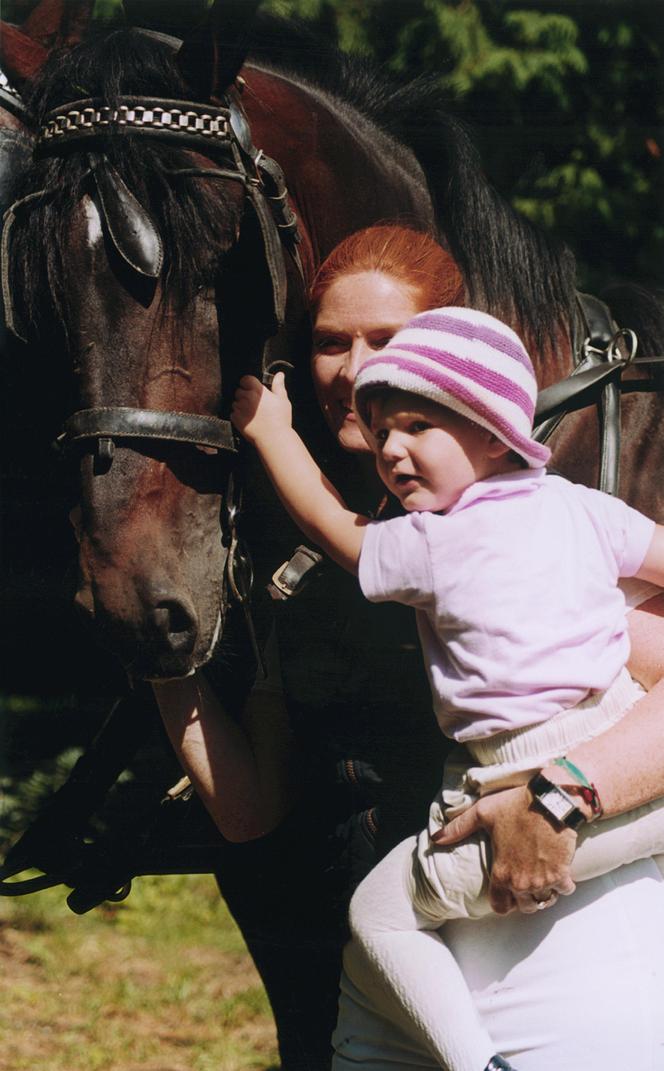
[353, 305, 550, 468]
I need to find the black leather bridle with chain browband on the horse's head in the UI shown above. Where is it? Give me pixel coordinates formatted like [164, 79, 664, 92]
[2, 86, 301, 462]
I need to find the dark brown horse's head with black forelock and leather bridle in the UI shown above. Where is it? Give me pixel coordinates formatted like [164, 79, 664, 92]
[5, 18, 304, 679]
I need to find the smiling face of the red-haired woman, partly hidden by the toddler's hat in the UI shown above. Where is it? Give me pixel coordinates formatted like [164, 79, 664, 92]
[312, 271, 422, 452]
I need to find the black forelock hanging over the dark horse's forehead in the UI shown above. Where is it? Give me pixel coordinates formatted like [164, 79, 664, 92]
[12, 29, 244, 327]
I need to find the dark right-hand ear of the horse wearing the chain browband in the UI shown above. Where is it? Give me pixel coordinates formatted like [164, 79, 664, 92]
[178, 0, 260, 101]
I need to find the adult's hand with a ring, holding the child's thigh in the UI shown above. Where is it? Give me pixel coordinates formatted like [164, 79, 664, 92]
[432, 785, 576, 915]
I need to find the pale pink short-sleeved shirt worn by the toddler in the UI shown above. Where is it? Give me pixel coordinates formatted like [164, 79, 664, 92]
[359, 469, 654, 741]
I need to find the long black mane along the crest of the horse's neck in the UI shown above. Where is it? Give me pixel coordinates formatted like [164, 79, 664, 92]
[246, 15, 576, 359]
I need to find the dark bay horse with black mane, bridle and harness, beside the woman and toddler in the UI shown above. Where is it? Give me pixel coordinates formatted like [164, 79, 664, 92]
[4, 3, 664, 1062]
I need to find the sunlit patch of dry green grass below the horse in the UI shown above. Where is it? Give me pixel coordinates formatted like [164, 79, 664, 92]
[0, 875, 278, 1071]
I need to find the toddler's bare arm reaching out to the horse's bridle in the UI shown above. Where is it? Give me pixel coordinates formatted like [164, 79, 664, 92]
[230, 372, 368, 573]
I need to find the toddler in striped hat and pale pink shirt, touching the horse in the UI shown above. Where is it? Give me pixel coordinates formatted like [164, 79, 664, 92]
[232, 307, 664, 1071]
